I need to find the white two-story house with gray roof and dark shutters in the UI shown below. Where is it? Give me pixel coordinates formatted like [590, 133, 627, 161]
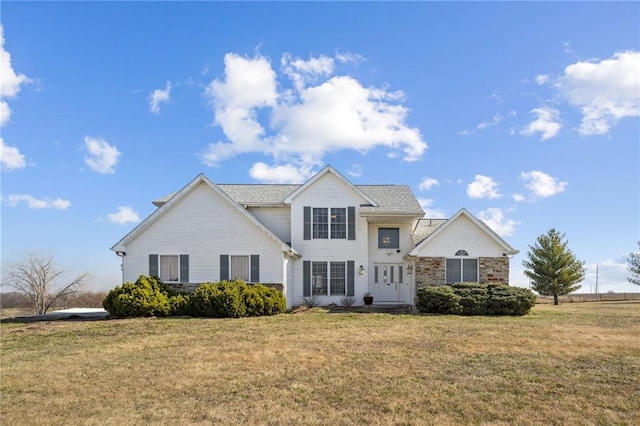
[111, 166, 518, 307]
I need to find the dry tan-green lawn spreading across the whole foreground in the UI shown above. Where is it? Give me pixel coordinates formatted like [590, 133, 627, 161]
[0, 302, 640, 425]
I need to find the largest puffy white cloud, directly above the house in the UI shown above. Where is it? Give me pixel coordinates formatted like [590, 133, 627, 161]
[202, 53, 427, 176]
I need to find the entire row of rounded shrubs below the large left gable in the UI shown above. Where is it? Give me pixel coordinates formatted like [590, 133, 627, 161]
[103, 276, 286, 318]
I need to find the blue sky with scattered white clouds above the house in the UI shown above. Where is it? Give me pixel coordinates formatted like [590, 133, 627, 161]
[0, 2, 640, 292]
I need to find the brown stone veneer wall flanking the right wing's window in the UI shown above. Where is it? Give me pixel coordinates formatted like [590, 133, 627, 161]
[416, 256, 509, 289]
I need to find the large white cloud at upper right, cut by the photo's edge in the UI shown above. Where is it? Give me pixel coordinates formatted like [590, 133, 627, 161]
[556, 51, 640, 135]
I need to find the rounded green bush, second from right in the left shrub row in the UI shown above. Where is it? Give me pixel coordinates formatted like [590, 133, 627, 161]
[189, 281, 247, 318]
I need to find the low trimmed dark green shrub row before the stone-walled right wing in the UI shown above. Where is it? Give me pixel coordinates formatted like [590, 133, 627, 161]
[415, 283, 536, 315]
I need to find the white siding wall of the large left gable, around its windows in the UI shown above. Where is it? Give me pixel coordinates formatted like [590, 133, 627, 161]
[123, 182, 285, 284]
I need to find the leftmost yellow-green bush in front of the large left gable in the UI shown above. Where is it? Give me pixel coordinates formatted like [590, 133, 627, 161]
[102, 275, 171, 317]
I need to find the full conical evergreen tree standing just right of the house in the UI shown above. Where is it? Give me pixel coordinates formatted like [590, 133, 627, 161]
[522, 228, 585, 305]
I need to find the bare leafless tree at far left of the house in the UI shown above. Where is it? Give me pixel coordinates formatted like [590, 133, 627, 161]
[2, 253, 89, 315]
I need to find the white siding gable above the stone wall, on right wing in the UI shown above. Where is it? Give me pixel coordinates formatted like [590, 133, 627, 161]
[412, 215, 505, 257]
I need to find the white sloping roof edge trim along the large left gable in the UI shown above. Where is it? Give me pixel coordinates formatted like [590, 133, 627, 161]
[111, 173, 295, 254]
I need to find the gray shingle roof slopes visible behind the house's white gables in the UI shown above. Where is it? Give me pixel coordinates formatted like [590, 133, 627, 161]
[153, 184, 424, 215]
